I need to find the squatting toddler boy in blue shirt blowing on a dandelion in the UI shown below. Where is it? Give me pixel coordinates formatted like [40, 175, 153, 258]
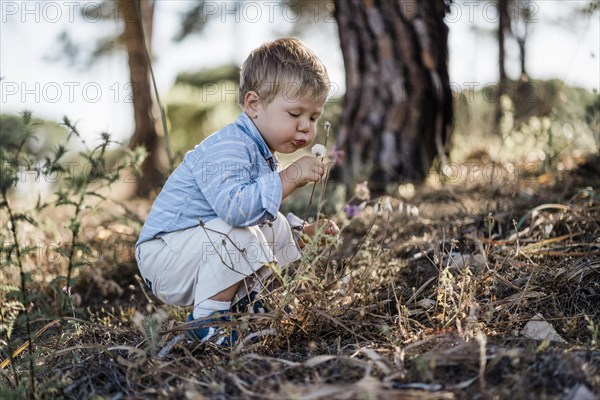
[136, 38, 339, 346]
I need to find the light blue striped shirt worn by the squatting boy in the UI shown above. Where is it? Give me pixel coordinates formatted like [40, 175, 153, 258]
[136, 112, 282, 245]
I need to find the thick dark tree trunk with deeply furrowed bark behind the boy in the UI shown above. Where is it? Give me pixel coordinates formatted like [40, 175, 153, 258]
[335, 0, 452, 193]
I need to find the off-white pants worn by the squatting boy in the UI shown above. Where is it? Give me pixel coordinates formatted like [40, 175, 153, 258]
[136, 213, 301, 306]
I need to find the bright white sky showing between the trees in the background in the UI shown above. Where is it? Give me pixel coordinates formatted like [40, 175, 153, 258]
[0, 0, 600, 141]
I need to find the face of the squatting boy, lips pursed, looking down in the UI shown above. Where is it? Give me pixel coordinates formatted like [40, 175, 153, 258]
[251, 93, 325, 154]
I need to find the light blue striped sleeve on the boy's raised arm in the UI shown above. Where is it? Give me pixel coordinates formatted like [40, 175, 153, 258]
[191, 138, 283, 227]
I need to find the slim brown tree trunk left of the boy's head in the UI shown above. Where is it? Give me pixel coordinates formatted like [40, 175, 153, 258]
[119, 0, 164, 197]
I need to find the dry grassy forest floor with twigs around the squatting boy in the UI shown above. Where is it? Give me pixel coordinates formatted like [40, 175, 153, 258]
[0, 157, 600, 400]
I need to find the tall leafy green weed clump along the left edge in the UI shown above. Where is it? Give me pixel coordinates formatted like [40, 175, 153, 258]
[0, 111, 143, 399]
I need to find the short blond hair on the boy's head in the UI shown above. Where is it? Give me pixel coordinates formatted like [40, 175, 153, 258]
[238, 38, 329, 105]
